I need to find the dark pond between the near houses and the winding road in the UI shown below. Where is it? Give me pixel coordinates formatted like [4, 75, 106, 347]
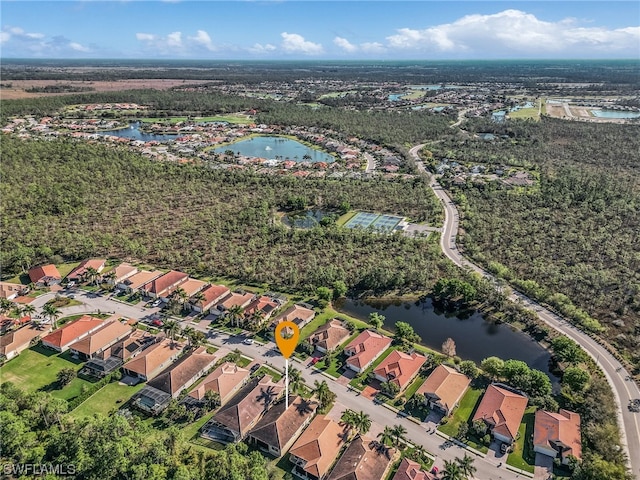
[335, 299, 559, 387]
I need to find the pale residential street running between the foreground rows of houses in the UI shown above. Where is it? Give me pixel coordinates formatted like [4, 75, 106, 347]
[32, 291, 527, 480]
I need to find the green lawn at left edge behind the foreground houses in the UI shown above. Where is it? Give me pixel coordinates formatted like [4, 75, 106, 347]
[0, 347, 91, 400]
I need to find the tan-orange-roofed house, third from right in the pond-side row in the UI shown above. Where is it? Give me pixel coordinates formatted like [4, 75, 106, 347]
[416, 365, 471, 415]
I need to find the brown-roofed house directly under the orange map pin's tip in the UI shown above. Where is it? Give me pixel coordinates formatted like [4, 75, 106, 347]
[249, 395, 318, 457]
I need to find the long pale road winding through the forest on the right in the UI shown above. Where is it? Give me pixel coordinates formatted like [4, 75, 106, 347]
[409, 144, 640, 478]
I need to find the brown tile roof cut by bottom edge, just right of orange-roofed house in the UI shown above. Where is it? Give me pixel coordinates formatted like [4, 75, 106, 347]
[328, 436, 396, 480]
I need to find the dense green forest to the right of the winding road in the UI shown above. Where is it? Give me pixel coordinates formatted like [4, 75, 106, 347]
[429, 118, 640, 372]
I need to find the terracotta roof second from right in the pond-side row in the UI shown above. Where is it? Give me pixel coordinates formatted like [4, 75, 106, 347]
[473, 384, 528, 440]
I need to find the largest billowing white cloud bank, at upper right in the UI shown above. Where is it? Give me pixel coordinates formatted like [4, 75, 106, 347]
[387, 9, 640, 57]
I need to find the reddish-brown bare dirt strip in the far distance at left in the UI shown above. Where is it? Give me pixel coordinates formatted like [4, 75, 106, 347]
[0, 79, 205, 100]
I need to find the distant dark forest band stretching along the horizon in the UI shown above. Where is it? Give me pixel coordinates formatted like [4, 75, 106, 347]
[0, 59, 638, 86]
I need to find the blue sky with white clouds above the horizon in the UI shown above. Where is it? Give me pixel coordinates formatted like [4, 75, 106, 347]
[0, 0, 640, 60]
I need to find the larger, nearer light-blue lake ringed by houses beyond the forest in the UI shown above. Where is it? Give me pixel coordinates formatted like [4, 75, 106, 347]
[213, 135, 335, 163]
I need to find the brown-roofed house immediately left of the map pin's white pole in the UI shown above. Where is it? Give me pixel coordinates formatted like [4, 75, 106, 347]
[201, 375, 285, 443]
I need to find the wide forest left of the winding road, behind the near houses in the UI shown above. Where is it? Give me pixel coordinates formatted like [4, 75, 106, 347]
[0, 136, 455, 292]
